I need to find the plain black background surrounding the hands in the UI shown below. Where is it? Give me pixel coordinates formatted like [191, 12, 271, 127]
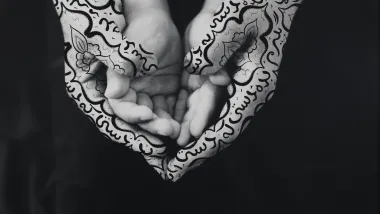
[0, 0, 379, 214]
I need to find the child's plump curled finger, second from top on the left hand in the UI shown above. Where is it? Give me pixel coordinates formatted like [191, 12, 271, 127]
[108, 89, 153, 123]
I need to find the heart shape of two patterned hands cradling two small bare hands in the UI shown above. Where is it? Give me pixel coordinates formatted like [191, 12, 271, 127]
[54, 0, 302, 181]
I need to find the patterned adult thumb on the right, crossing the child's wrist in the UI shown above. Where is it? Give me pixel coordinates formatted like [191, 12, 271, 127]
[184, 1, 258, 75]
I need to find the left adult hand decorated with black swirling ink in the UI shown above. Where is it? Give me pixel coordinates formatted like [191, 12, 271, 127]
[53, 0, 167, 179]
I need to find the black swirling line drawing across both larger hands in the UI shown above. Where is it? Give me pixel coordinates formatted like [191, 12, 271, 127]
[53, 0, 301, 181]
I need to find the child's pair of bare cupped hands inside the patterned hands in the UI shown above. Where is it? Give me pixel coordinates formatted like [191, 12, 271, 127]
[105, 0, 230, 147]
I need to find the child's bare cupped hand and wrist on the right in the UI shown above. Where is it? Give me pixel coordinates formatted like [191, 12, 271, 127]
[175, 12, 230, 146]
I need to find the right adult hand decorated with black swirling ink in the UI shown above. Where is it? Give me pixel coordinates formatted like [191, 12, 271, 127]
[167, 0, 302, 181]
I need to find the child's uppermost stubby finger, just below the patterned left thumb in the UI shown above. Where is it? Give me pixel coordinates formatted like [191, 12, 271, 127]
[104, 69, 131, 99]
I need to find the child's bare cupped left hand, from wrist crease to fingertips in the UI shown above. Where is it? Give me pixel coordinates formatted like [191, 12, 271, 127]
[106, 11, 182, 137]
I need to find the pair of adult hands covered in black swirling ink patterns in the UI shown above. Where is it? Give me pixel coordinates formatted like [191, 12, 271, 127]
[53, 0, 302, 181]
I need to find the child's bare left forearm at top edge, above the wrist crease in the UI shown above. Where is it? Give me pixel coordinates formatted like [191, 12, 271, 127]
[124, 0, 170, 20]
